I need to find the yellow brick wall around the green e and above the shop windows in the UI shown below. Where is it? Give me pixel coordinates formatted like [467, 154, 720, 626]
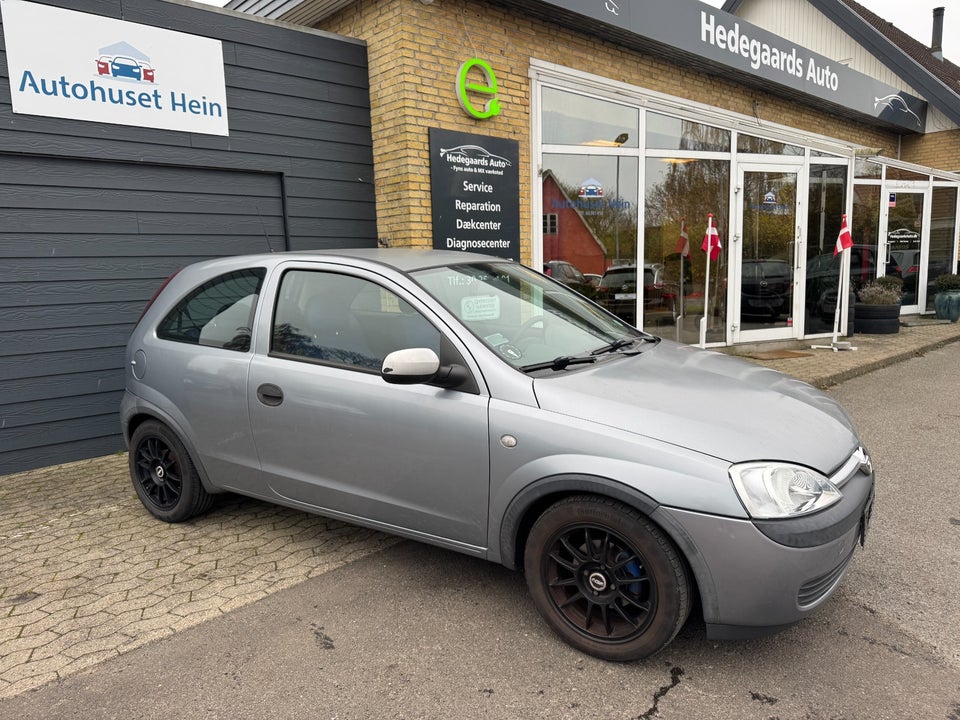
[319, 0, 897, 261]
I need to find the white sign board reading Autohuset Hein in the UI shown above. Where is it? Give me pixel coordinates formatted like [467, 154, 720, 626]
[0, 0, 230, 135]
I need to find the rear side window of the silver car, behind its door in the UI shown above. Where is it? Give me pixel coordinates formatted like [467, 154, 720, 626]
[157, 268, 266, 352]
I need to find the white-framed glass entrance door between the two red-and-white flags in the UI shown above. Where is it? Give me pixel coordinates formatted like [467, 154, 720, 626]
[729, 164, 802, 342]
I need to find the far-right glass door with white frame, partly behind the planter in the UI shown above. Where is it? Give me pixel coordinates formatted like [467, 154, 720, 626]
[881, 190, 927, 314]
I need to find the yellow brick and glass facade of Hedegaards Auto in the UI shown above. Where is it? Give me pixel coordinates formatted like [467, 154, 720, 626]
[228, 0, 960, 345]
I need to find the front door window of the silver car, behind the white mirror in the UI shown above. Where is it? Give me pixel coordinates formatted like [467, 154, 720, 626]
[271, 270, 440, 372]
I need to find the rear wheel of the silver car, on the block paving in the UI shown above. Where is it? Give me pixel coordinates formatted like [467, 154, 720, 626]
[129, 420, 213, 523]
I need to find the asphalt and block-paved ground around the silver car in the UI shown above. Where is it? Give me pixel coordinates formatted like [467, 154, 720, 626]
[0, 326, 960, 720]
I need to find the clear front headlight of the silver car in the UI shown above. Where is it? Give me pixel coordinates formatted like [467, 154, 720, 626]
[730, 462, 843, 519]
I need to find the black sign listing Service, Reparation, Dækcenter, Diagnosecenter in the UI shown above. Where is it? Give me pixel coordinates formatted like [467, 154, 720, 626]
[430, 128, 520, 261]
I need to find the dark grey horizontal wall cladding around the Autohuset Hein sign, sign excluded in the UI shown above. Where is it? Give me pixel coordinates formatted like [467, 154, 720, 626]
[0, 0, 377, 475]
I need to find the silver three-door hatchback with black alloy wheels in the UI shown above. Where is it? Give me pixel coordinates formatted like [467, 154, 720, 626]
[122, 249, 874, 660]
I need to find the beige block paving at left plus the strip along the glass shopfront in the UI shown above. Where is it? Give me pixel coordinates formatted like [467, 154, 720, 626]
[0, 320, 960, 701]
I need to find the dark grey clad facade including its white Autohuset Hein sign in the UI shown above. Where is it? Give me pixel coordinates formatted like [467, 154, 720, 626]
[0, 0, 376, 475]
